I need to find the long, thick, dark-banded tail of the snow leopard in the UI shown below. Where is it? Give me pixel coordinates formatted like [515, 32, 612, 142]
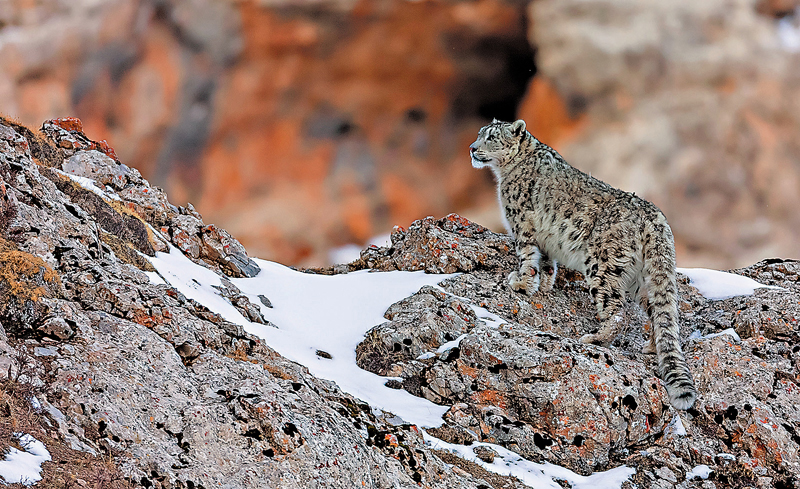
[643, 212, 697, 409]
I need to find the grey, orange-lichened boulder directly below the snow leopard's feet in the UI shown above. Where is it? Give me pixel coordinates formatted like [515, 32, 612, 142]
[357, 282, 669, 473]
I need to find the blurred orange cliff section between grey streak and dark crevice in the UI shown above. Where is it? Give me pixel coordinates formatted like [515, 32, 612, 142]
[194, 1, 536, 263]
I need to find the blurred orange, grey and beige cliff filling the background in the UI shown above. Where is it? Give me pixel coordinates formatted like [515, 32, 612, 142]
[0, 0, 800, 268]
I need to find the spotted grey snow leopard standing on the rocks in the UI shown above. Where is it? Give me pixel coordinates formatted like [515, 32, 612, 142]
[469, 120, 697, 409]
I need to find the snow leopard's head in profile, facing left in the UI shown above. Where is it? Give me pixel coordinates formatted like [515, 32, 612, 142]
[469, 119, 528, 171]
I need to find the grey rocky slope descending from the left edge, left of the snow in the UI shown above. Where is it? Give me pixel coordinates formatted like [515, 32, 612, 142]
[0, 121, 488, 488]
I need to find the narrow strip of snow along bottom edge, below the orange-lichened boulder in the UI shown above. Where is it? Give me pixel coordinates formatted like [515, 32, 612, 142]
[422, 431, 636, 489]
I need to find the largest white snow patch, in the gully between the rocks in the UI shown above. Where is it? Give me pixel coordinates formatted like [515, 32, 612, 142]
[150, 247, 452, 427]
